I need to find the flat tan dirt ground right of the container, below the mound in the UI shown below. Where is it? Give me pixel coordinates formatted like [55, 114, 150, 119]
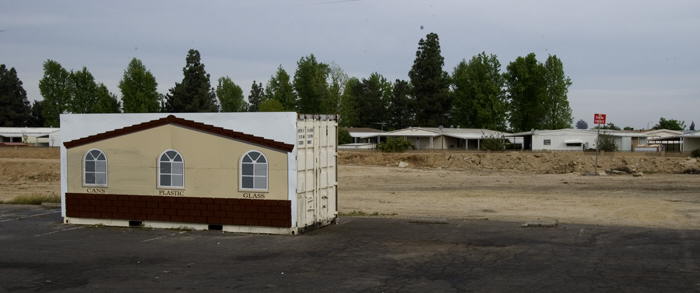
[339, 166, 700, 229]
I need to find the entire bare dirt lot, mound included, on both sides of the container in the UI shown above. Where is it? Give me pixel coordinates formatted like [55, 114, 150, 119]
[0, 148, 700, 229]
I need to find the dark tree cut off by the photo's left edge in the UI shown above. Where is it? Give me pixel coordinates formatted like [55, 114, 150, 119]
[0, 64, 31, 127]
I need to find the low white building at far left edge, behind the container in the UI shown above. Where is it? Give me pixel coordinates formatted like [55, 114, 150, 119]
[0, 127, 61, 147]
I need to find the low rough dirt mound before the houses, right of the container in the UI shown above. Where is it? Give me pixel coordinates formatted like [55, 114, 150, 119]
[338, 151, 700, 174]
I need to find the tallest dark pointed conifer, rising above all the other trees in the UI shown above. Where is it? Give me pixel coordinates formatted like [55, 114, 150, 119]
[408, 33, 451, 126]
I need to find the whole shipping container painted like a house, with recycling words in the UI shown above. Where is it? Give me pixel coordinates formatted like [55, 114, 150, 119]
[61, 113, 337, 234]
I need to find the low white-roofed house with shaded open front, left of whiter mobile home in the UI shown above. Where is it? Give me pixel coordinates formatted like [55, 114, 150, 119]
[382, 127, 507, 150]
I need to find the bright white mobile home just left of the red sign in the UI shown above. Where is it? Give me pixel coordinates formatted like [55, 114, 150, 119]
[506, 129, 598, 151]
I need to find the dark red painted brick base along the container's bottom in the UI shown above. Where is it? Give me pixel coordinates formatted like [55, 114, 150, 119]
[66, 193, 292, 228]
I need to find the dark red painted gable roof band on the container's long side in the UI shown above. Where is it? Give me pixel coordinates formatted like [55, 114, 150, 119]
[63, 115, 294, 152]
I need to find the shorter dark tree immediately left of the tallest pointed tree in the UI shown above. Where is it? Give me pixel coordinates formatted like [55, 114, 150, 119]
[387, 79, 415, 129]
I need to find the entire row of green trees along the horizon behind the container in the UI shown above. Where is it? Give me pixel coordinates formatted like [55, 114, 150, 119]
[0, 33, 572, 131]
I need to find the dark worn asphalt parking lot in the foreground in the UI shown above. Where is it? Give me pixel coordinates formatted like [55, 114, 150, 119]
[0, 205, 700, 292]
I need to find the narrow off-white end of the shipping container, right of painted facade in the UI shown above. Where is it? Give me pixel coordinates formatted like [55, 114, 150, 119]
[296, 115, 338, 229]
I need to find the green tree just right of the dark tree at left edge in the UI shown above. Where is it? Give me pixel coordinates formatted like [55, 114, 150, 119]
[39, 59, 71, 127]
